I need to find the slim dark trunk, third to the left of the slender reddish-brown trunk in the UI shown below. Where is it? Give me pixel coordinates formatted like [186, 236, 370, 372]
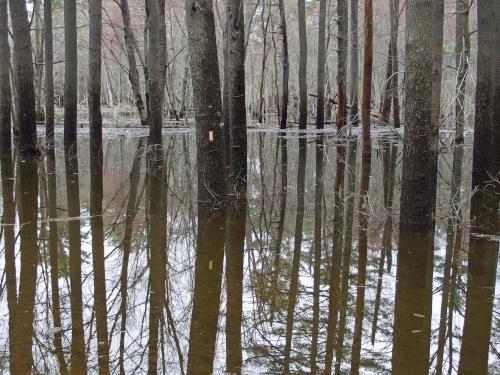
[316, 0, 328, 129]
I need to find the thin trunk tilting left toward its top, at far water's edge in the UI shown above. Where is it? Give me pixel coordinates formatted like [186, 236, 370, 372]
[120, 0, 148, 125]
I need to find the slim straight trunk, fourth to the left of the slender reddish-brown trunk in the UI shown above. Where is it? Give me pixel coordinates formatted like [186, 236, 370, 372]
[298, 0, 307, 129]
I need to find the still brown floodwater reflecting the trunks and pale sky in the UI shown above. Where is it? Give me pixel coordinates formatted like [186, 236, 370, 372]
[0, 130, 500, 375]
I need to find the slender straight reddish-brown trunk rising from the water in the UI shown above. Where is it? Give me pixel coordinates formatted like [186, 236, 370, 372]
[361, 0, 373, 145]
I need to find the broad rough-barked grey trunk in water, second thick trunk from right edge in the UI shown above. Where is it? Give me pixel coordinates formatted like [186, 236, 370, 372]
[400, 0, 437, 229]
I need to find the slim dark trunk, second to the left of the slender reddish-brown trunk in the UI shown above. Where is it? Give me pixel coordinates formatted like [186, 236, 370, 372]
[337, 0, 348, 130]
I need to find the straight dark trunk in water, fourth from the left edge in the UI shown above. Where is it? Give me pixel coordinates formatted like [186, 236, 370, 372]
[64, 0, 78, 147]
